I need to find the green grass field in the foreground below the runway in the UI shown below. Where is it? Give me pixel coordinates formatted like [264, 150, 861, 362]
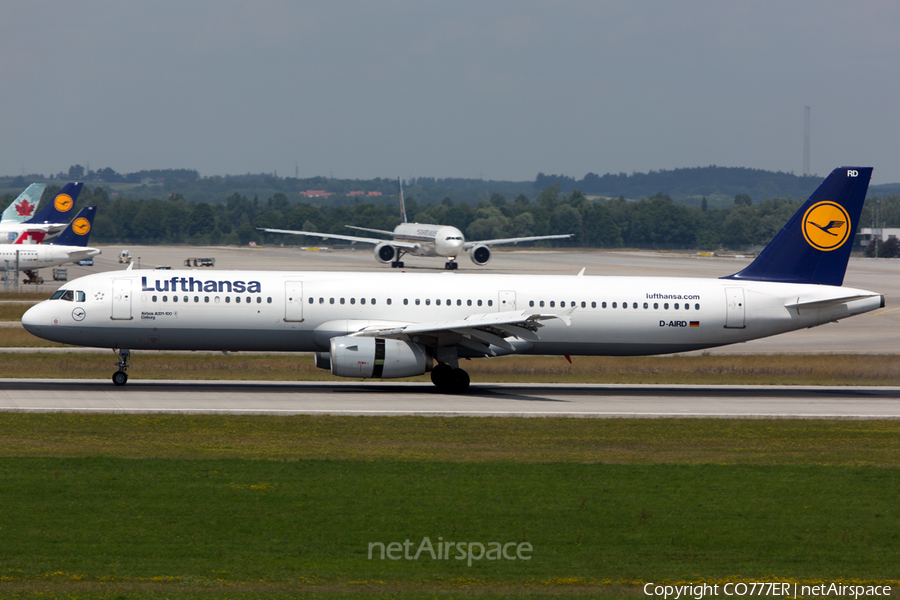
[0, 413, 900, 598]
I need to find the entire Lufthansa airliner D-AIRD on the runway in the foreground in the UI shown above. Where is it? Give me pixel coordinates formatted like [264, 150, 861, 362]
[22, 167, 884, 393]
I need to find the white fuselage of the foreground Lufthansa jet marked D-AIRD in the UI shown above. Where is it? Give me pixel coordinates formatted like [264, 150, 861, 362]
[22, 270, 883, 356]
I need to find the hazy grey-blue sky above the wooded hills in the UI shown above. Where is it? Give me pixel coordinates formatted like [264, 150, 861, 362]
[0, 0, 900, 183]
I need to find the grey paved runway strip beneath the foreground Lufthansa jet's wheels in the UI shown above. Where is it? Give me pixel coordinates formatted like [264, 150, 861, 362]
[0, 379, 900, 419]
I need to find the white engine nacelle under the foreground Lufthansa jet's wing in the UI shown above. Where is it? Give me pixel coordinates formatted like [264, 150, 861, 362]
[331, 336, 428, 379]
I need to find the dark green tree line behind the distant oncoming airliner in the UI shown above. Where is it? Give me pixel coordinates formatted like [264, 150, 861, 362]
[3, 184, 900, 250]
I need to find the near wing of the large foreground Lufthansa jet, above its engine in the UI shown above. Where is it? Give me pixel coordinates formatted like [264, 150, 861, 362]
[351, 306, 575, 355]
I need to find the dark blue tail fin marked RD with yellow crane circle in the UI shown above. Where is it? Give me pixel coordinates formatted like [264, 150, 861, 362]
[723, 167, 872, 286]
